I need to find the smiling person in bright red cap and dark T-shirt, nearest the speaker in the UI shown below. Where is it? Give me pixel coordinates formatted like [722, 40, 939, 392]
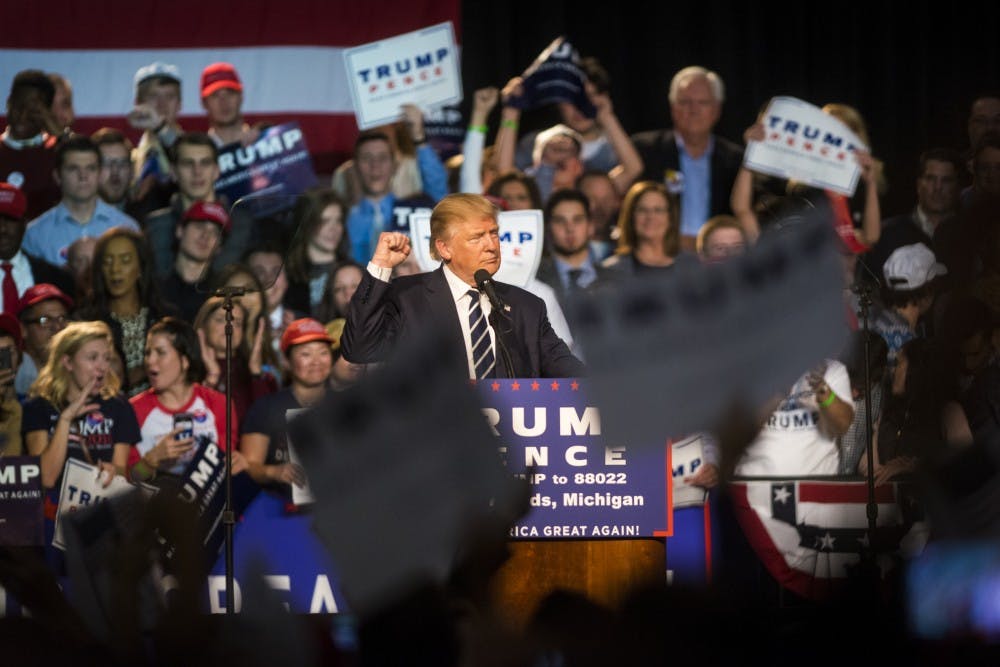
[240, 317, 333, 500]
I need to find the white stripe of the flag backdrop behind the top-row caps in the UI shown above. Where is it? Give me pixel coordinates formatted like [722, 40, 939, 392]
[0, 46, 354, 117]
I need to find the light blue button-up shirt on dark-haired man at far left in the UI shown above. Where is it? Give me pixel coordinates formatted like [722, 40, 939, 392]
[21, 199, 139, 266]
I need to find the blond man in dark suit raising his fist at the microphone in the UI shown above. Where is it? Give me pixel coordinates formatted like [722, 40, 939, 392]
[341, 194, 584, 379]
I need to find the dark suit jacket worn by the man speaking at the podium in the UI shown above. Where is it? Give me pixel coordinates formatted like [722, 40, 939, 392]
[340, 267, 585, 378]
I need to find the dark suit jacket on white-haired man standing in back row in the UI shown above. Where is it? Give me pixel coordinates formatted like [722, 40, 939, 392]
[632, 130, 743, 220]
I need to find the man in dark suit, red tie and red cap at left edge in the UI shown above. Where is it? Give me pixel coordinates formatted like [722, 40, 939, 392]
[0, 183, 75, 313]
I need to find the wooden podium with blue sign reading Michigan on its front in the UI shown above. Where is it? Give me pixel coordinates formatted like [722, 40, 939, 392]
[478, 378, 670, 626]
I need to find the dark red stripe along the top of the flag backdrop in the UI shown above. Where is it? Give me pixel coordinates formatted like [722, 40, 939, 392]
[0, 0, 461, 49]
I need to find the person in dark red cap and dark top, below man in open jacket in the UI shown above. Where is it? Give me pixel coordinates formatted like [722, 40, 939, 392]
[160, 201, 231, 322]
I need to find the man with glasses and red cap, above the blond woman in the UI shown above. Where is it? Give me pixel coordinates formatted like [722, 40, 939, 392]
[14, 283, 73, 396]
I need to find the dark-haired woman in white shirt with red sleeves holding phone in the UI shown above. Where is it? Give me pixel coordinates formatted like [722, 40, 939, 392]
[130, 317, 246, 480]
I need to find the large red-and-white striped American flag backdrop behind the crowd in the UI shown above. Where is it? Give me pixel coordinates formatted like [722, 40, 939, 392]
[0, 0, 461, 173]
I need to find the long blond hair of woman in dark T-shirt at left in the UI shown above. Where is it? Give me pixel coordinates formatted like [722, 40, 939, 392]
[28, 321, 121, 410]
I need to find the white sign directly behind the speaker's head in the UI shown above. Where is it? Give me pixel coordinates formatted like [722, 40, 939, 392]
[410, 210, 544, 287]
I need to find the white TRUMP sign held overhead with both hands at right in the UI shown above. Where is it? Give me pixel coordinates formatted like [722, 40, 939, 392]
[743, 97, 868, 197]
